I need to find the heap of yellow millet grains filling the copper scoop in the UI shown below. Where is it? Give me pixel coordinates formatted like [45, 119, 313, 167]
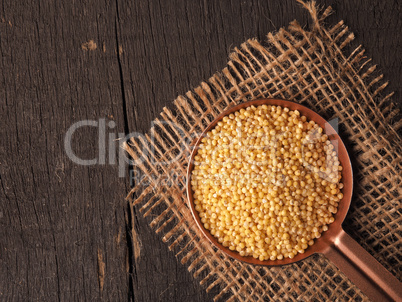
[190, 105, 343, 261]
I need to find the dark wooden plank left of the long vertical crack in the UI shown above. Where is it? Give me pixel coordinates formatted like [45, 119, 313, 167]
[0, 1, 128, 301]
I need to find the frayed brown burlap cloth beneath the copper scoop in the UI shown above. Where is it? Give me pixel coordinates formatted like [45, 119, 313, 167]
[125, 2, 402, 301]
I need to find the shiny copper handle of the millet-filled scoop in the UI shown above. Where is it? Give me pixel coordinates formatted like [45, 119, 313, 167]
[324, 230, 402, 301]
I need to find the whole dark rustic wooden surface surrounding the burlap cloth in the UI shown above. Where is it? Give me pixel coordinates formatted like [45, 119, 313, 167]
[0, 0, 402, 301]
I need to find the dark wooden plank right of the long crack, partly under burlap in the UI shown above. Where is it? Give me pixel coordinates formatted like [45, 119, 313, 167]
[118, 0, 401, 301]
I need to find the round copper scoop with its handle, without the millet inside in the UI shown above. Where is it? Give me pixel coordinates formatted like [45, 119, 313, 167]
[186, 99, 402, 301]
